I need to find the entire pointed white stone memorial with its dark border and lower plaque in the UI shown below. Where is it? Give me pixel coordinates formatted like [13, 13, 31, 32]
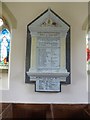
[25, 9, 70, 92]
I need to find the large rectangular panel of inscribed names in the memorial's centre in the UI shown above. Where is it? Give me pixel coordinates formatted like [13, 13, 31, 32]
[37, 37, 60, 70]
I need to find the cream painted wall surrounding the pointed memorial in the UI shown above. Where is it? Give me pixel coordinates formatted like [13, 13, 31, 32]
[2, 3, 88, 103]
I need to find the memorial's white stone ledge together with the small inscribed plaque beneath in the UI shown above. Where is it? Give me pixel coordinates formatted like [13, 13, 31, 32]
[27, 68, 69, 92]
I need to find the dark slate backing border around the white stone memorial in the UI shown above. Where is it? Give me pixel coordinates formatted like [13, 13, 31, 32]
[25, 9, 71, 91]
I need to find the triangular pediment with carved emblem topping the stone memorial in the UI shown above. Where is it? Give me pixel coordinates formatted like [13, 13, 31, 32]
[28, 9, 70, 32]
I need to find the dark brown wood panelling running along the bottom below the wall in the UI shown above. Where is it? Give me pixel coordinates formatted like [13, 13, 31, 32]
[0, 103, 90, 120]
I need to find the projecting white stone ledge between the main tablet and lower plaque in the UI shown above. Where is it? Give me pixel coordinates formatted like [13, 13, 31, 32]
[27, 69, 69, 81]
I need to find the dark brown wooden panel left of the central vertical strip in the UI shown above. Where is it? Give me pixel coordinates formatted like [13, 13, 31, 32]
[13, 104, 50, 120]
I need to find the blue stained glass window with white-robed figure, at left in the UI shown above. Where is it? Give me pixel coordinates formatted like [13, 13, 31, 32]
[0, 28, 10, 69]
